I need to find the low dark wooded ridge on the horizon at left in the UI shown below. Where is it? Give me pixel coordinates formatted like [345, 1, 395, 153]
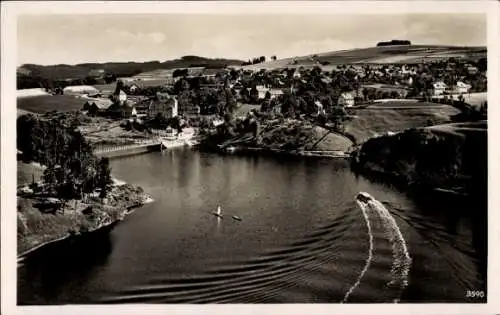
[18, 56, 243, 80]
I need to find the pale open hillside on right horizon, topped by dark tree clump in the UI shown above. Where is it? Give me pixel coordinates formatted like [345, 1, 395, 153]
[243, 42, 487, 70]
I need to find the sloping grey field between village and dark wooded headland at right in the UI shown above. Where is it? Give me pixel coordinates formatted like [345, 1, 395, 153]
[346, 103, 460, 143]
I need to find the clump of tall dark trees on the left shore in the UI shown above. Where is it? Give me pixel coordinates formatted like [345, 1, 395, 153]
[17, 115, 112, 200]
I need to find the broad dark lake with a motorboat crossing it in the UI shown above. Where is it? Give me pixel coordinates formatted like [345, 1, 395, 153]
[18, 149, 486, 305]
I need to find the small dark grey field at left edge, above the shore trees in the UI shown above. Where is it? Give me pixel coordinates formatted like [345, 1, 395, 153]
[17, 95, 85, 113]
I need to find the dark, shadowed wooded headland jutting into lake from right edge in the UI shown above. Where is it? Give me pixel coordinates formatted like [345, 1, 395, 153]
[352, 122, 488, 200]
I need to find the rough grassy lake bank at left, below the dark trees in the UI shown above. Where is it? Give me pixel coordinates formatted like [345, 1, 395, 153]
[17, 184, 150, 258]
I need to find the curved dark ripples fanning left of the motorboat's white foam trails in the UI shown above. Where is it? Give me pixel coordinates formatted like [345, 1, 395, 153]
[103, 206, 376, 303]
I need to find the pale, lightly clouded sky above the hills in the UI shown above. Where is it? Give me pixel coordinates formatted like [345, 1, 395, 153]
[17, 14, 487, 66]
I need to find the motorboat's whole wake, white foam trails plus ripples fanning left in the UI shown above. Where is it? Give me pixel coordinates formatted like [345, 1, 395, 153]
[100, 194, 411, 304]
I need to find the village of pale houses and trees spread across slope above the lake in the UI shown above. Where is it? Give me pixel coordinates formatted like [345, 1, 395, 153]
[18, 51, 487, 154]
